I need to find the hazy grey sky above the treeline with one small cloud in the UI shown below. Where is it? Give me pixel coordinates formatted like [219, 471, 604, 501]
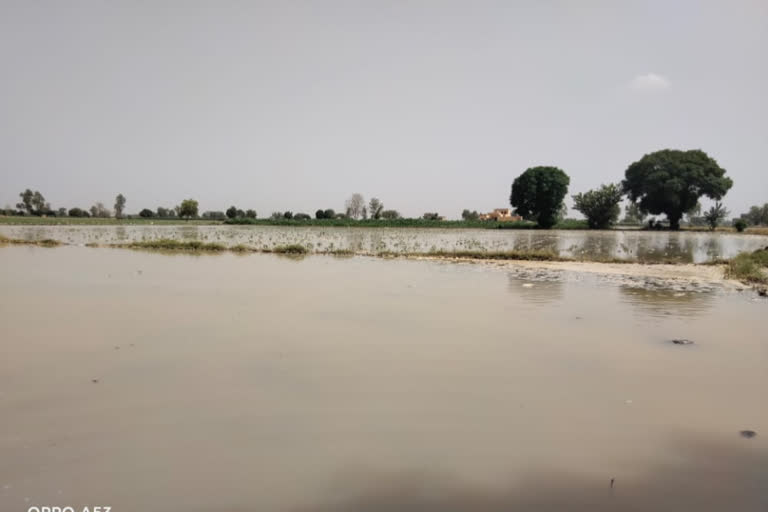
[0, 0, 768, 217]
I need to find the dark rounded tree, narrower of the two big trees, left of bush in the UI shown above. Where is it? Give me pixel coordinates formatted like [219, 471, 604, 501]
[509, 167, 571, 228]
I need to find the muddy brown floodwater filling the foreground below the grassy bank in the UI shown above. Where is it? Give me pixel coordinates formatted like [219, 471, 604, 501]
[0, 246, 768, 512]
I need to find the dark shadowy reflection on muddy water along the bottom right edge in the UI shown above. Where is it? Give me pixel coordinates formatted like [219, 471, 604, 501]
[296, 438, 768, 512]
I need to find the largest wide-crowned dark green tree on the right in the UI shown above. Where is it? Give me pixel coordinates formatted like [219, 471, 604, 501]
[622, 149, 733, 229]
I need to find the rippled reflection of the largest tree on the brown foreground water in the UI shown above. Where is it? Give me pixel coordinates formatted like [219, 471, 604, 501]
[619, 286, 715, 317]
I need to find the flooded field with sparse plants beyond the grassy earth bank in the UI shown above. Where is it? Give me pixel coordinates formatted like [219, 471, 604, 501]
[0, 225, 768, 263]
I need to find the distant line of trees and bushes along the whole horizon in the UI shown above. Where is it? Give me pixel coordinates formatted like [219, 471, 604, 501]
[6, 149, 768, 231]
